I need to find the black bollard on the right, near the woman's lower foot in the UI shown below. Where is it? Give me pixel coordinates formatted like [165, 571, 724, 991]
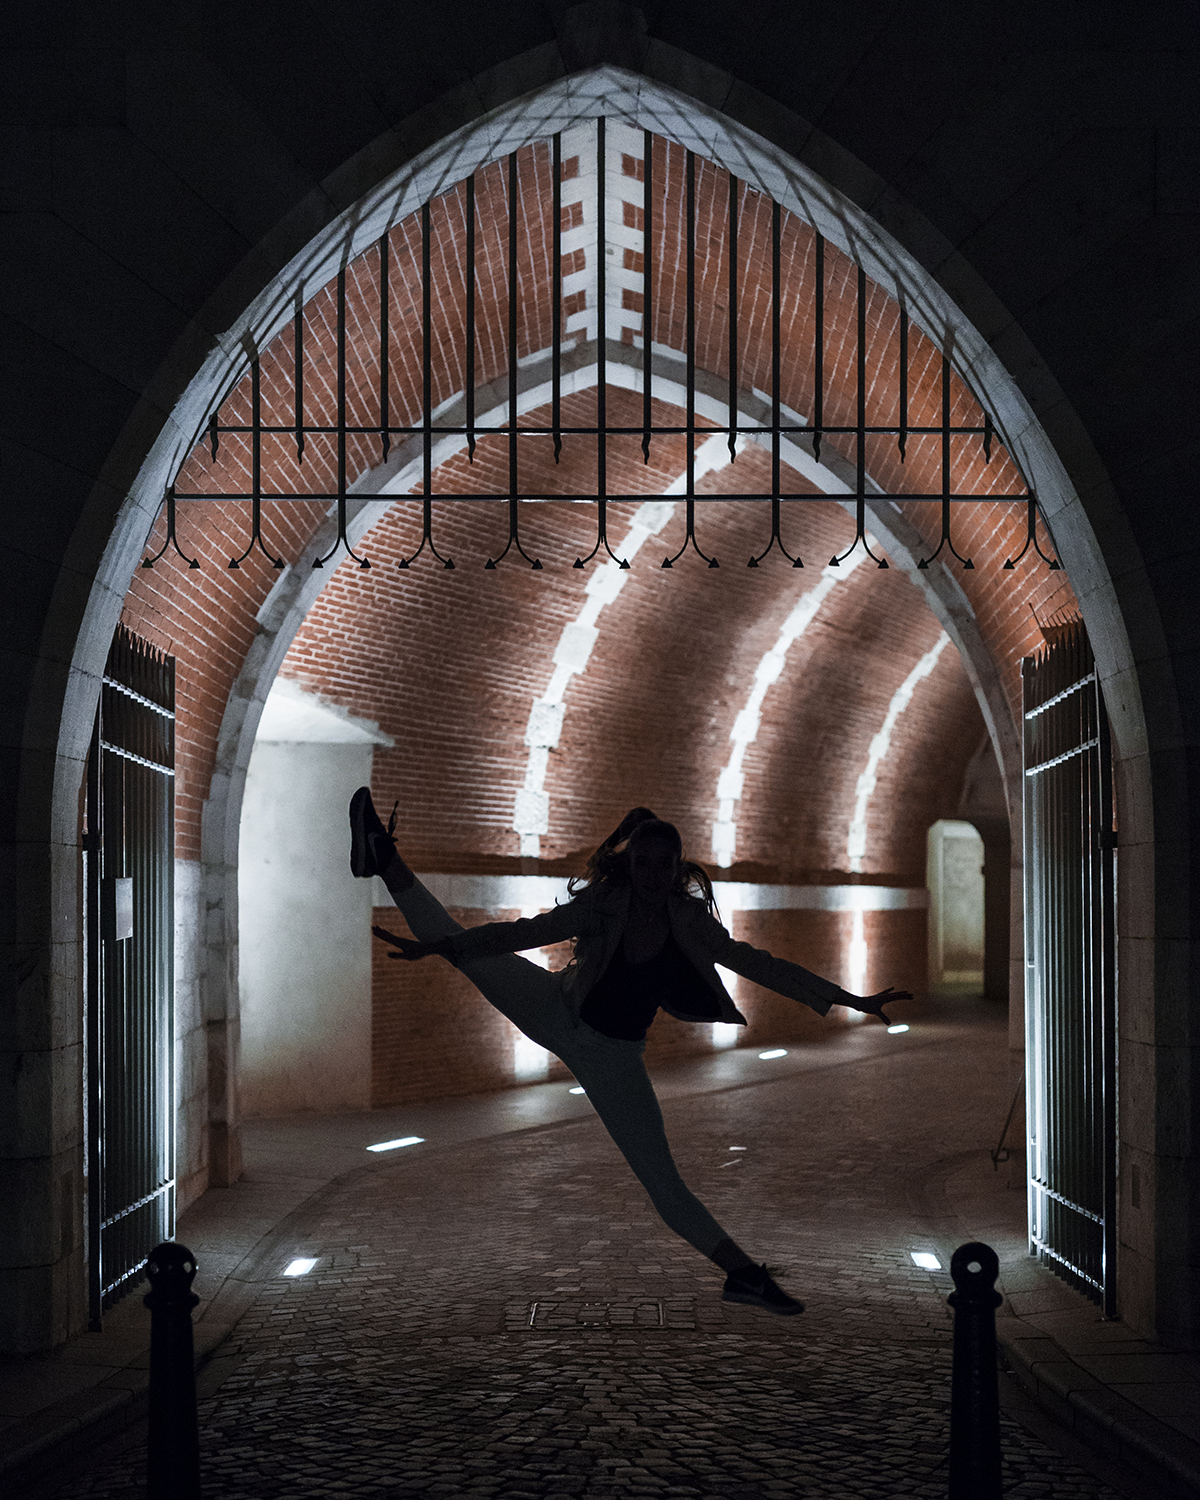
[950, 1244, 1004, 1500]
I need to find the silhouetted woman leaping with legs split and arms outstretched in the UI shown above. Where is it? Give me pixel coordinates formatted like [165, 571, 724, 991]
[350, 786, 912, 1313]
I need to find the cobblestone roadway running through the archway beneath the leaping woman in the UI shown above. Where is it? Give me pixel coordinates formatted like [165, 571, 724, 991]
[44, 1025, 1115, 1500]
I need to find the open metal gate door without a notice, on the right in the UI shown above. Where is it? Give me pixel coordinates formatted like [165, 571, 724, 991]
[1022, 623, 1116, 1316]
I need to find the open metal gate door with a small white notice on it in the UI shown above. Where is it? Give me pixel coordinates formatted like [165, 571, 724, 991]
[84, 627, 176, 1328]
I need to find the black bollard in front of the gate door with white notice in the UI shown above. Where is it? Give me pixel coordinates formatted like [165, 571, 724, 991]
[143, 1242, 200, 1500]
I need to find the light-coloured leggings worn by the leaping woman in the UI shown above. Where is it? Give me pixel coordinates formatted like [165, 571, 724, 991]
[393, 881, 729, 1256]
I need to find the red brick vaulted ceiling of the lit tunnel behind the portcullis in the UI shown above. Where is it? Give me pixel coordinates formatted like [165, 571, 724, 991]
[125, 132, 1073, 884]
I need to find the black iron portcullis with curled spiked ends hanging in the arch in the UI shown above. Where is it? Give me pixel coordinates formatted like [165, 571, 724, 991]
[143, 117, 1059, 569]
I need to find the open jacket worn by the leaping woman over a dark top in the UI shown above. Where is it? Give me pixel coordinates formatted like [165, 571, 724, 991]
[452, 884, 858, 1026]
